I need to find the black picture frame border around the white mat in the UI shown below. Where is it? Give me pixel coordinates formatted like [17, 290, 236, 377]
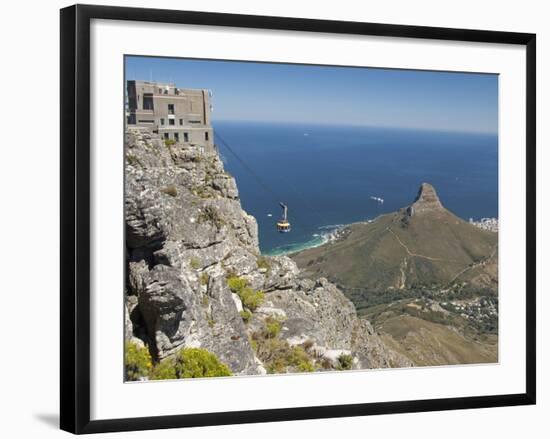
[60, 5, 536, 434]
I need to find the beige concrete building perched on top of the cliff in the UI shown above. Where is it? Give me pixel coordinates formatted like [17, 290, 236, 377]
[127, 80, 214, 151]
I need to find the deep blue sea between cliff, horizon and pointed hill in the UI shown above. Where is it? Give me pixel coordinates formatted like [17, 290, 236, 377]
[214, 122, 498, 254]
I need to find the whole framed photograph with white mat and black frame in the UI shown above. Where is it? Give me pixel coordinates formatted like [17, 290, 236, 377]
[61, 5, 536, 433]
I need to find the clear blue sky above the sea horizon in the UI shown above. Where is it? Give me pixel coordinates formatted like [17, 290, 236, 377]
[126, 57, 498, 133]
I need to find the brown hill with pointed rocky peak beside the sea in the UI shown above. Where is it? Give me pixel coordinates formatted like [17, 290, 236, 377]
[293, 183, 498, 292]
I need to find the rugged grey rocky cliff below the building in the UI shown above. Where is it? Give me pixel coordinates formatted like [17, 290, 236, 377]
[125, 129, 411, 374]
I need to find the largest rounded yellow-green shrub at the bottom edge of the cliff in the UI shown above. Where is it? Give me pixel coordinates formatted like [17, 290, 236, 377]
[152, 348, 231, 380]
